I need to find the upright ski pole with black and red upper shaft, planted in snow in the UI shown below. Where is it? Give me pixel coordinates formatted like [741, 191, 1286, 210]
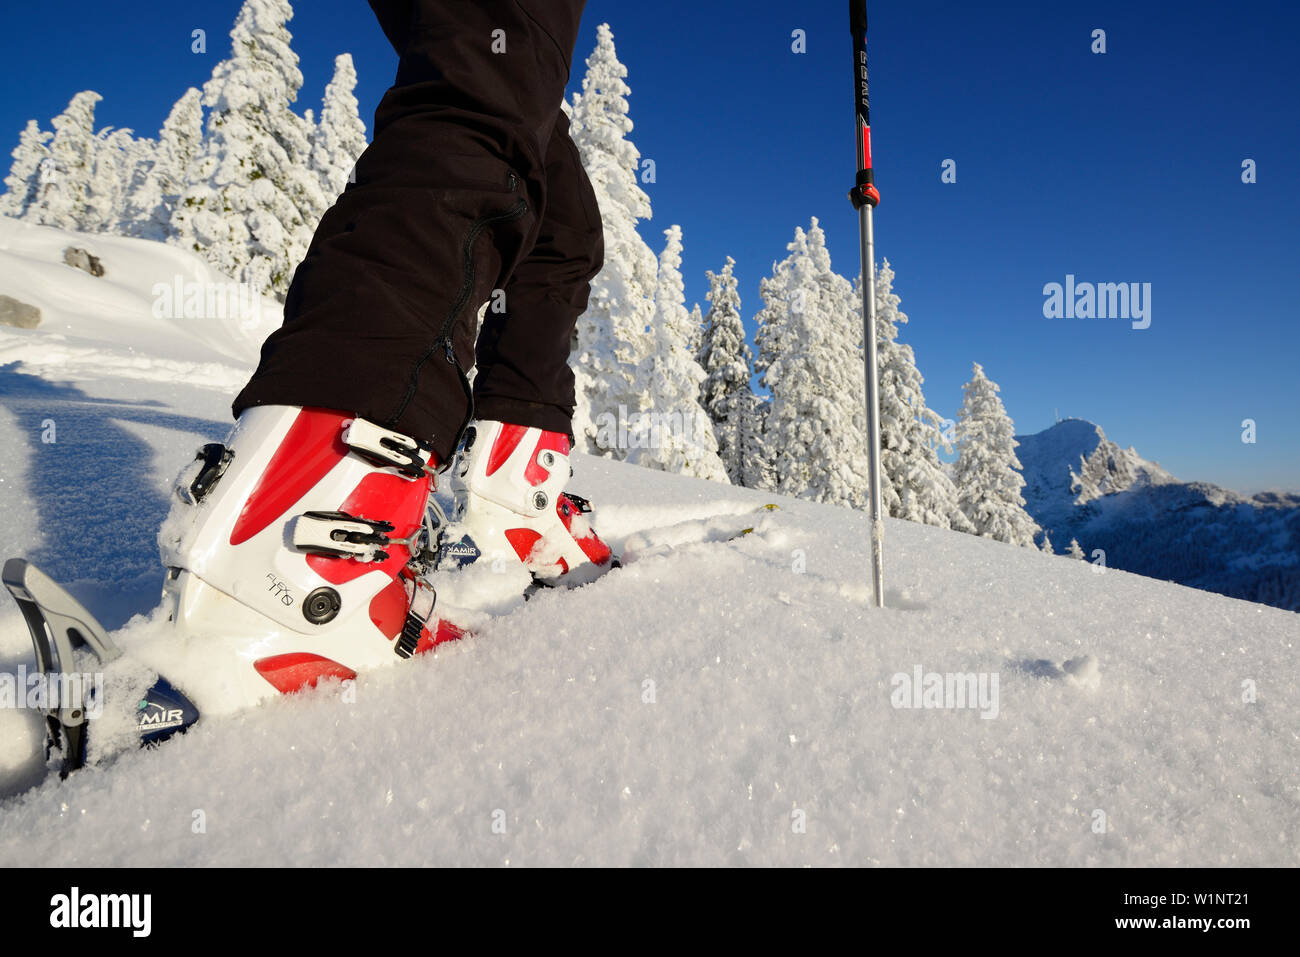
[849, 0, 885, 609]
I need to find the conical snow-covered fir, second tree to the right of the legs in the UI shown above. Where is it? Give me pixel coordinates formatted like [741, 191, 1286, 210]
[625, 226, 728, 482]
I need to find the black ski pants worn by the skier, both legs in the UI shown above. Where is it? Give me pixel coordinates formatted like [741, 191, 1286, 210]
[234, 0, 605, 462]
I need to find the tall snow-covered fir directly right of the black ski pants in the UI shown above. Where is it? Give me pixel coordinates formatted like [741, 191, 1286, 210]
[568, 23, 658, 459]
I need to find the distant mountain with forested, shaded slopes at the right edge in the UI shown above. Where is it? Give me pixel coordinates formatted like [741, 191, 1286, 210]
[1017, 419, 1300, 611]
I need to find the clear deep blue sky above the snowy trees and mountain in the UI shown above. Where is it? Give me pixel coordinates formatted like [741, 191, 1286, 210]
[0, 0, 1300, 492]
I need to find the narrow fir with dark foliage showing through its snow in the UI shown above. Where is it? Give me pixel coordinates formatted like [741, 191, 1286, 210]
[697, 256, 757, 485]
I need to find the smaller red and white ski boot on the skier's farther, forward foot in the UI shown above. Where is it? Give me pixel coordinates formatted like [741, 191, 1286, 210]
[441, 419, 615, 584]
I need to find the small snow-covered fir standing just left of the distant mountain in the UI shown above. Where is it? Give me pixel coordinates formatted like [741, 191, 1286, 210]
[956, 363, 1039, 547]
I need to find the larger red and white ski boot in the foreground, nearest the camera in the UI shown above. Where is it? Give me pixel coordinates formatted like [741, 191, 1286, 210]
[159, 406, 462, 710]
